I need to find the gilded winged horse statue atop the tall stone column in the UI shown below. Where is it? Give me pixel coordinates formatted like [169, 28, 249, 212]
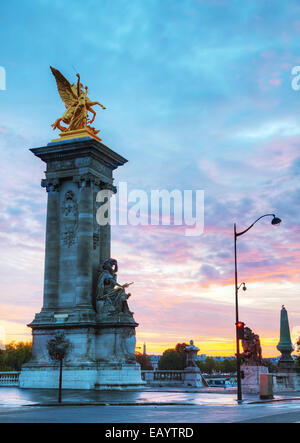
[50, 66, 106, 140]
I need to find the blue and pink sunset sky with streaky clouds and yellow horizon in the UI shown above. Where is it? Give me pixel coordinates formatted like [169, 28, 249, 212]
[0, 0, 300, 357]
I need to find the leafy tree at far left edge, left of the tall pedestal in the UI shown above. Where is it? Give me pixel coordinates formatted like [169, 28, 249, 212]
[0, 341, 32, 371]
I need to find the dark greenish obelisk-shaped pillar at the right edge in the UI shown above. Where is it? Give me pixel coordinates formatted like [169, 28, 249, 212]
[277, 306, 295, 372]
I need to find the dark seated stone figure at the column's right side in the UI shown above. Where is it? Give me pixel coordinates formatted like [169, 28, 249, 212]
[96, 258, 133, 316]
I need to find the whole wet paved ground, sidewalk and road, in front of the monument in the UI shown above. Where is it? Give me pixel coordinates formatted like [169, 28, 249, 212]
[0, 388, 300, 424]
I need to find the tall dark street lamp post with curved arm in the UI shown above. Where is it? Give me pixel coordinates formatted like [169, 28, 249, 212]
[234, 214, 281, 402]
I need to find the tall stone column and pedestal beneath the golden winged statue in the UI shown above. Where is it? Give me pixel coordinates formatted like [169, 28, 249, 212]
[20, 137, 143, 389]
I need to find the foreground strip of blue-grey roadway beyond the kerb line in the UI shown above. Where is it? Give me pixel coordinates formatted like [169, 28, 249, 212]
[0, 401, 300, 423]
